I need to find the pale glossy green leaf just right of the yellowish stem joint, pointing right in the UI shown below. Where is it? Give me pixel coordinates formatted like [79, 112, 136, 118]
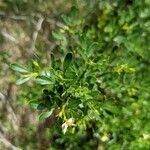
[36, 76, 53, 85]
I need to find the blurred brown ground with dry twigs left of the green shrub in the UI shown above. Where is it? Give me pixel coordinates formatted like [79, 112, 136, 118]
[0, 0, 77, 150]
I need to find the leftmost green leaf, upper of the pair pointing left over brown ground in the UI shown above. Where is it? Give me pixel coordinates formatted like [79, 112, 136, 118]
[10, 64, 29, 73]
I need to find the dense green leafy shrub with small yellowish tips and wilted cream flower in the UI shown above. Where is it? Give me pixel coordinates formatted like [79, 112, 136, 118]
[11, 0, 150, 150]
